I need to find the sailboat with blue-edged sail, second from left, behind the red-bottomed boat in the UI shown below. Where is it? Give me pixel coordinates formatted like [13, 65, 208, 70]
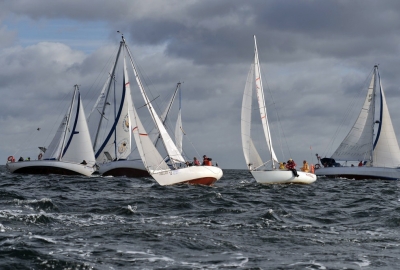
[88, 38, 149, 177]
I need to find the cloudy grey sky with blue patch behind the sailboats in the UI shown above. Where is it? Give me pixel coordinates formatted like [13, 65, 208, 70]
[0, 0, 400, 169]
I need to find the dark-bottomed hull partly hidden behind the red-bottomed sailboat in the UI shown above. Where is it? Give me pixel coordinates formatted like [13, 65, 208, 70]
[99, 160, 150, 177]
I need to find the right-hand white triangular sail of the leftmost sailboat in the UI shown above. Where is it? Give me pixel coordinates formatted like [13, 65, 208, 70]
[62, 94, 95, 165]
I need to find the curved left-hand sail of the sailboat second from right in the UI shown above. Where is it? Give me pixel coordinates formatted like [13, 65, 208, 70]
[241, 64, 263, 169]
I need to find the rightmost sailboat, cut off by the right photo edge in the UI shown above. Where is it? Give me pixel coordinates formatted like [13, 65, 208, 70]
[315, 65, 400, 180]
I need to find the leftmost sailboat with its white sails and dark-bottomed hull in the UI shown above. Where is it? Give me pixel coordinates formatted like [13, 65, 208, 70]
[6, 85, 95, 176]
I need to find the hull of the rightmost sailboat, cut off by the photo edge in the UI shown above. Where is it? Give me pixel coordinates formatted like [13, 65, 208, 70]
[315, 167, 400, 180]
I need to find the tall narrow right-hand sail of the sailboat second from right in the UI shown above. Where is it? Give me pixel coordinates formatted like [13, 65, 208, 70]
[254, 36, 278, 162]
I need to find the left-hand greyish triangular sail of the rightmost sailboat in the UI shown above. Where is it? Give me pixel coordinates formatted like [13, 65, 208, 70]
[332, 72, 377, 161]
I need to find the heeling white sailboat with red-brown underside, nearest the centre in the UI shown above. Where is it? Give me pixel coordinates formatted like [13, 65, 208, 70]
[122, 37, 223, 186]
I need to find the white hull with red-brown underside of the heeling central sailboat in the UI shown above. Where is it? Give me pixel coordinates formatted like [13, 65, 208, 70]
[152, 166, 223, 186]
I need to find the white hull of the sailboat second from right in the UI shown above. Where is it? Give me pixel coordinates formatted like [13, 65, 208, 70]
[250, 170, 317, 184]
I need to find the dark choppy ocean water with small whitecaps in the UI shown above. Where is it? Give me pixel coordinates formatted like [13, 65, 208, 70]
[0, 166, 400, 269]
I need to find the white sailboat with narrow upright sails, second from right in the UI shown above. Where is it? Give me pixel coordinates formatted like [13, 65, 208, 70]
[241, 36, 317, 184]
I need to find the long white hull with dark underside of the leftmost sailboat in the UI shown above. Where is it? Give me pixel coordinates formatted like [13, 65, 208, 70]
[6, 160, 95, 176]
